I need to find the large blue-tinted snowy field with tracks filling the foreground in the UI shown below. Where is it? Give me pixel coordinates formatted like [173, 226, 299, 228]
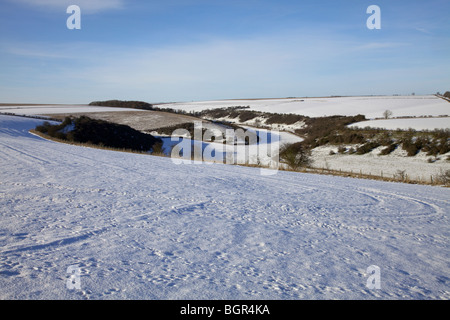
[0, 116, 450, 300]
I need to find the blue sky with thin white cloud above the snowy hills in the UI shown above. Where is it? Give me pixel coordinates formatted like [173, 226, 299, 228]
[0, 0, 450, 103]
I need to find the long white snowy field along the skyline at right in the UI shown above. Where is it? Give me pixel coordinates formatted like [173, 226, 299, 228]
[159, 95, 450, 119]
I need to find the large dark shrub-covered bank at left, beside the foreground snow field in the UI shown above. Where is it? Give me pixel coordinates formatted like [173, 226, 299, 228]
[36, 116, 162, 152]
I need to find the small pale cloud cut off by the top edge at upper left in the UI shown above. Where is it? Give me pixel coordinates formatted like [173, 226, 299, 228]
[10, 0, 124, 14]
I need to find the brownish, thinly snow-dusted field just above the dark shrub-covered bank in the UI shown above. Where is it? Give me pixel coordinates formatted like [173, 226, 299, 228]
[43, 110, 205, 131]
